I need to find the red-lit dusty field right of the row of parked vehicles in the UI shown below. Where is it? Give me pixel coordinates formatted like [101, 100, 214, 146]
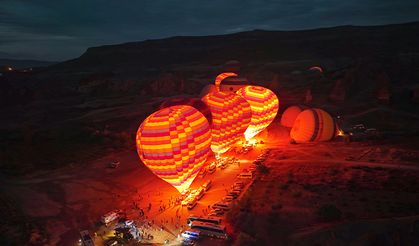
[229, 139, 419, 245]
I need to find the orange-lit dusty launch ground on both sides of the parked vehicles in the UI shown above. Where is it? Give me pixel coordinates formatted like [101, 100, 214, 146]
[1, 129, 419, 245]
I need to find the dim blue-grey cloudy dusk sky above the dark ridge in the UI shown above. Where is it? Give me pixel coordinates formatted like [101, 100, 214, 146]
[0, 0, 419, 61]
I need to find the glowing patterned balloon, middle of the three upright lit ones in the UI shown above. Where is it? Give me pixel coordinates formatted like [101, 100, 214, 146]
[202, 91, 252, 154]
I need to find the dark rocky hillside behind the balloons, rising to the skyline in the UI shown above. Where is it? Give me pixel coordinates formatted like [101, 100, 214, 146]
[0, 22, 419, 175]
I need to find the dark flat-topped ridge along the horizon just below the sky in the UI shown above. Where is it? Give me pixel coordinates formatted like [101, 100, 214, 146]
[53, 23, 419, 72]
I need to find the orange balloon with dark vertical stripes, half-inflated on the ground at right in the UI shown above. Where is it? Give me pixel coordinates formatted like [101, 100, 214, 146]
[290, 108, 336, 143]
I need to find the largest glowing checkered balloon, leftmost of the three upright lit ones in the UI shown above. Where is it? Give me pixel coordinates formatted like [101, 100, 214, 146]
[136, 105, 211, 192]
